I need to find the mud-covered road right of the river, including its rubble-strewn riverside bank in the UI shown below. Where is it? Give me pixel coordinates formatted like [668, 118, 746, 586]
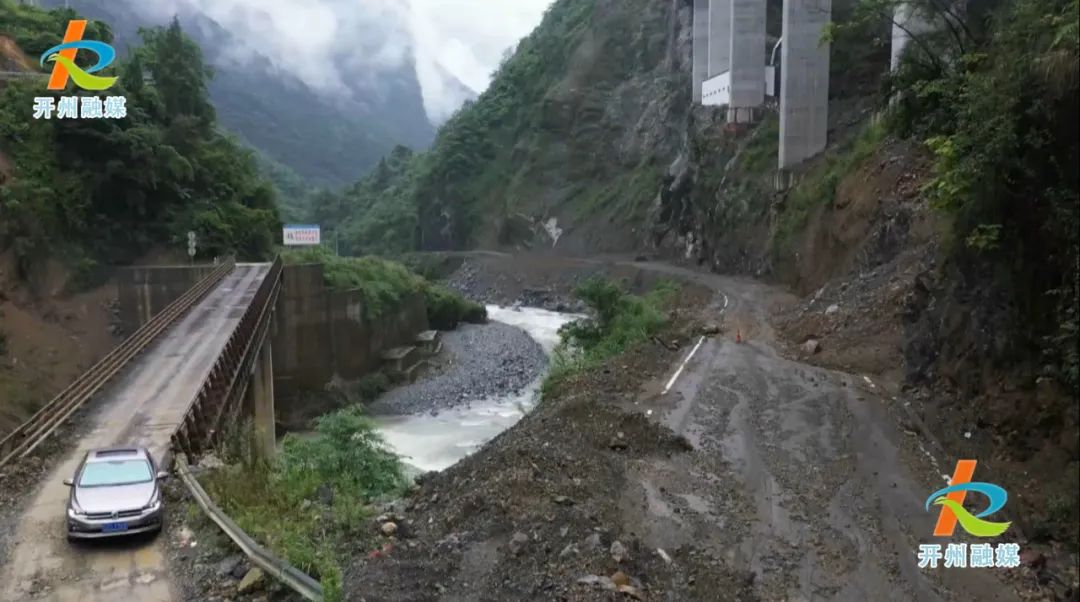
[347, 253, 1019, 602]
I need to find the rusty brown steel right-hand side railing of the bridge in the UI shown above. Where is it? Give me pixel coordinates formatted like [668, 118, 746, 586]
[171, 256, 282, 460]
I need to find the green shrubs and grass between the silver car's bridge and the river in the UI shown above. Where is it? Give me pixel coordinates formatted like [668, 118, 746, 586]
[203, 406, 407, 600]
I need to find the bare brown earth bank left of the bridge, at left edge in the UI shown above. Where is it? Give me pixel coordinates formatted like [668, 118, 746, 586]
[0, 253, 120, 434]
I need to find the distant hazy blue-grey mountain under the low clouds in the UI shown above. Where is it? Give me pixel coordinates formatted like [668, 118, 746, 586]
[43, 0, 434, 184]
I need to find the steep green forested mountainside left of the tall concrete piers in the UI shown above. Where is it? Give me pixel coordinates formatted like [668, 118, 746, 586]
[289, 0, 673, 251]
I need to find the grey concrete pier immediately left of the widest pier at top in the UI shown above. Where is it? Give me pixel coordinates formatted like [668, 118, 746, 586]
[728, 0, 766, 116]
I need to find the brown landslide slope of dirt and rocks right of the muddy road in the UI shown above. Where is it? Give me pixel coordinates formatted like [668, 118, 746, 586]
[775, 143, 1080, 579]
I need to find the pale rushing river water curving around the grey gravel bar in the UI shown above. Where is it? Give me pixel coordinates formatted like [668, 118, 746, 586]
[374, 306, 578, 471]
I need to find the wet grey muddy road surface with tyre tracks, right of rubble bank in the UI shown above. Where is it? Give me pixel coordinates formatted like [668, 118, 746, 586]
[623, 260, 1016, 601]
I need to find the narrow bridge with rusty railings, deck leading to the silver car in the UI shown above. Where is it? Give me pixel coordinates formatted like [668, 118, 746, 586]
[0, 260, 282, 602]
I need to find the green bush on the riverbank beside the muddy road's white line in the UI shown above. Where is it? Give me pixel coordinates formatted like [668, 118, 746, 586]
[543, 278, 678, 393]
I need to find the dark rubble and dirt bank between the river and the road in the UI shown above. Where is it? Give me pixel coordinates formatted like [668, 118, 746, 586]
[345, 283, 753, 601]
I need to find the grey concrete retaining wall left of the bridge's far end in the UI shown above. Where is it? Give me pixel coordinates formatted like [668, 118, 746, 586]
[117, 265, 216, 335]
